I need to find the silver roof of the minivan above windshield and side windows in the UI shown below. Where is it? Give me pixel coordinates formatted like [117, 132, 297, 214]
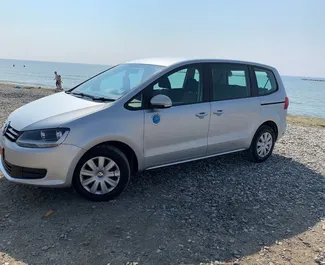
[127, 57, 274, 69]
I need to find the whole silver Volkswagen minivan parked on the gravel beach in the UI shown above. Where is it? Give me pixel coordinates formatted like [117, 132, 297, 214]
[0, 58, 289, 201]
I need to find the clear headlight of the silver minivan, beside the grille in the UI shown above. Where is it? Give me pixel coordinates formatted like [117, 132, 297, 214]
[17, 128, 70, 148]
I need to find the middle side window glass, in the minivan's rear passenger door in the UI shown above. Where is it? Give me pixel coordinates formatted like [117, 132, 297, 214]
[211, 63, 251, 101]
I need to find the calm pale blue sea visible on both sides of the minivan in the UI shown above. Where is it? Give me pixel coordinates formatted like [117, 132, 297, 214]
[0, 59, 325, 118]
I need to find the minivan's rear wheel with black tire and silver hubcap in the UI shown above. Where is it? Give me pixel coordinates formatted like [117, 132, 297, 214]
[247, 125, 275, 163]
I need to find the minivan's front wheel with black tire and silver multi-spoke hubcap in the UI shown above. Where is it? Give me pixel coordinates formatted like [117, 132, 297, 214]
[72, 145, 131, 201]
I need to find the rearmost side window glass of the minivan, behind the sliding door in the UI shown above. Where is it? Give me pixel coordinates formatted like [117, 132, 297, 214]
[254, 68, 278, 96]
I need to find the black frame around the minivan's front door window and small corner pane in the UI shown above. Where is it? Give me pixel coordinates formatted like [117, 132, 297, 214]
[124, 62, 210, 111]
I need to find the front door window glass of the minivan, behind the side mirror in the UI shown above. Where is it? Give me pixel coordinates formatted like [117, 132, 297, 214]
[152, 65, 203, 106]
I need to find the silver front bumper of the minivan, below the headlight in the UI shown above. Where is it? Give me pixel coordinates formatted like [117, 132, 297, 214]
[0, 137, 83, 187]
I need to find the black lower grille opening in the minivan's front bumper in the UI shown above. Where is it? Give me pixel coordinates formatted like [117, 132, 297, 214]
[2, 154, 47, 179]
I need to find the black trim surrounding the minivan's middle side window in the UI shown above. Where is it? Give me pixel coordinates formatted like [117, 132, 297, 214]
[206, 62, 254, 102]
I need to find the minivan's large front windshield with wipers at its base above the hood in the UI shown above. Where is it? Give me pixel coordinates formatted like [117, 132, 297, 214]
[68, 64, 164, 100]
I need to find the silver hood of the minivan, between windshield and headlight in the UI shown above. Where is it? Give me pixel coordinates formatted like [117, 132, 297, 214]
[7, 92, 108, 131]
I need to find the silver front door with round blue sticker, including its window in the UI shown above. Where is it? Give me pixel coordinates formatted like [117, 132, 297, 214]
[144, 64, 210, 168]
